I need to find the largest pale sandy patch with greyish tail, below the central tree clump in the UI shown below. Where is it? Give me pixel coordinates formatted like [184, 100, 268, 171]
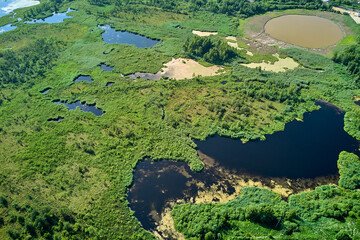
[129, 58, 223, 80]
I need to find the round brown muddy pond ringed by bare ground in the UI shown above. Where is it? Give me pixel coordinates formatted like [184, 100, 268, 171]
[264, 15, 343, 48]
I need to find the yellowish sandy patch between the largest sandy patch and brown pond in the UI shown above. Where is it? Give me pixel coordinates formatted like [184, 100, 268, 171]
[241, 54, 299, 73]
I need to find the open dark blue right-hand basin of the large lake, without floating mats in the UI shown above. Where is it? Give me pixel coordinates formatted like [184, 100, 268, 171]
[195, 103, 359, 178]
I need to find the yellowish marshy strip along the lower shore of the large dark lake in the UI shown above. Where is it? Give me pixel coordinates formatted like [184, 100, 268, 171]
[151, 151, 338, 239]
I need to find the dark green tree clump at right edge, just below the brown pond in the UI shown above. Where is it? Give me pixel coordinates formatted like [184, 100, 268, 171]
[332, 44, 360, 84]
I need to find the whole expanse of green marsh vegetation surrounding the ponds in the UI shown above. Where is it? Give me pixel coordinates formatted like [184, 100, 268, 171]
[0, 0, 360, 240]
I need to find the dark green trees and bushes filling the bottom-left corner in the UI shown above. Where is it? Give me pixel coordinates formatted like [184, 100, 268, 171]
[0, 194, 97, 240]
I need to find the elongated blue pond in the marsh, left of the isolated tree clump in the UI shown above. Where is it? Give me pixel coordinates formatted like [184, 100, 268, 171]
[98, 25, 160, 48]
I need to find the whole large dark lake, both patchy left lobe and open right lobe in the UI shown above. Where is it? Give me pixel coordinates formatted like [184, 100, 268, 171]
[128, 103, 359, 234]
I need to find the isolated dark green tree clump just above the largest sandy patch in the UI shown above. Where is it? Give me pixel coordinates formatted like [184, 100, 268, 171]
[183, 36, 239, 64]
